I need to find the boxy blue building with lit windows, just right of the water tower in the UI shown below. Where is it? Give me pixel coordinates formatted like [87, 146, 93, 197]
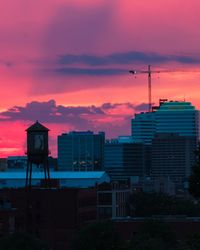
[58, 131, 105, 171]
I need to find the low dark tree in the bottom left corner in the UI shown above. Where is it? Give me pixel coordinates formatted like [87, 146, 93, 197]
[0, 233, 50, 250]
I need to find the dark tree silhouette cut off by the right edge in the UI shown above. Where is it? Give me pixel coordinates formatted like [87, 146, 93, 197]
[189, 144, 200, 199]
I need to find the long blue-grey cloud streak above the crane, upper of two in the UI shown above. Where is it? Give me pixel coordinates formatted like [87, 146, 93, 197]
[58, 51, 200, 66]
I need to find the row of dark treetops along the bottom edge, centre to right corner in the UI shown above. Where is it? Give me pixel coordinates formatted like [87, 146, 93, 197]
[71, 220, 200, 250]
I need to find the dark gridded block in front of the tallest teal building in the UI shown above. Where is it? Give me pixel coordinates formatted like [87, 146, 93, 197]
[151, 133, 196, 185]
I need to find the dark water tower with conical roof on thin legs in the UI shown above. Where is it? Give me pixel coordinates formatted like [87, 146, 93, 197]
[26, 121, 50, 187]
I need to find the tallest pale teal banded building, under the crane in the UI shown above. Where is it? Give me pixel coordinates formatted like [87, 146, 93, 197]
[132, 101, 199, 144]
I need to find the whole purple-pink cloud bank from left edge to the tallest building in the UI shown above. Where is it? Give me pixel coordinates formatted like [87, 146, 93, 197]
[0, 100, 148, 137]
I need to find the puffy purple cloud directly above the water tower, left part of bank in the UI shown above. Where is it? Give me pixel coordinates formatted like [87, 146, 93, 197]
[0, 100, 104, 127]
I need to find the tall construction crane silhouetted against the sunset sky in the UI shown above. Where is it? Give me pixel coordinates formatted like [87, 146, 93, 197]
[129, 65, 160, 112]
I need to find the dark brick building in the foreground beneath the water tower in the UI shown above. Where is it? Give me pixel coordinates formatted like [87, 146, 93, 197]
[0, 188, 97, 250]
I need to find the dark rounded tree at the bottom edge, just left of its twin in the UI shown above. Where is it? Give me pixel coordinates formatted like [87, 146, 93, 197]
[72, 221, 123, 250]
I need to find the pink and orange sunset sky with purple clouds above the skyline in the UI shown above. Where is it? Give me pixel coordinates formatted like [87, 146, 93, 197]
[0, 0, 200, 157]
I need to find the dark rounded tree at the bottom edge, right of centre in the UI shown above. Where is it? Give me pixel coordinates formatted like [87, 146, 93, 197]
[128, 220, 176, 250]
